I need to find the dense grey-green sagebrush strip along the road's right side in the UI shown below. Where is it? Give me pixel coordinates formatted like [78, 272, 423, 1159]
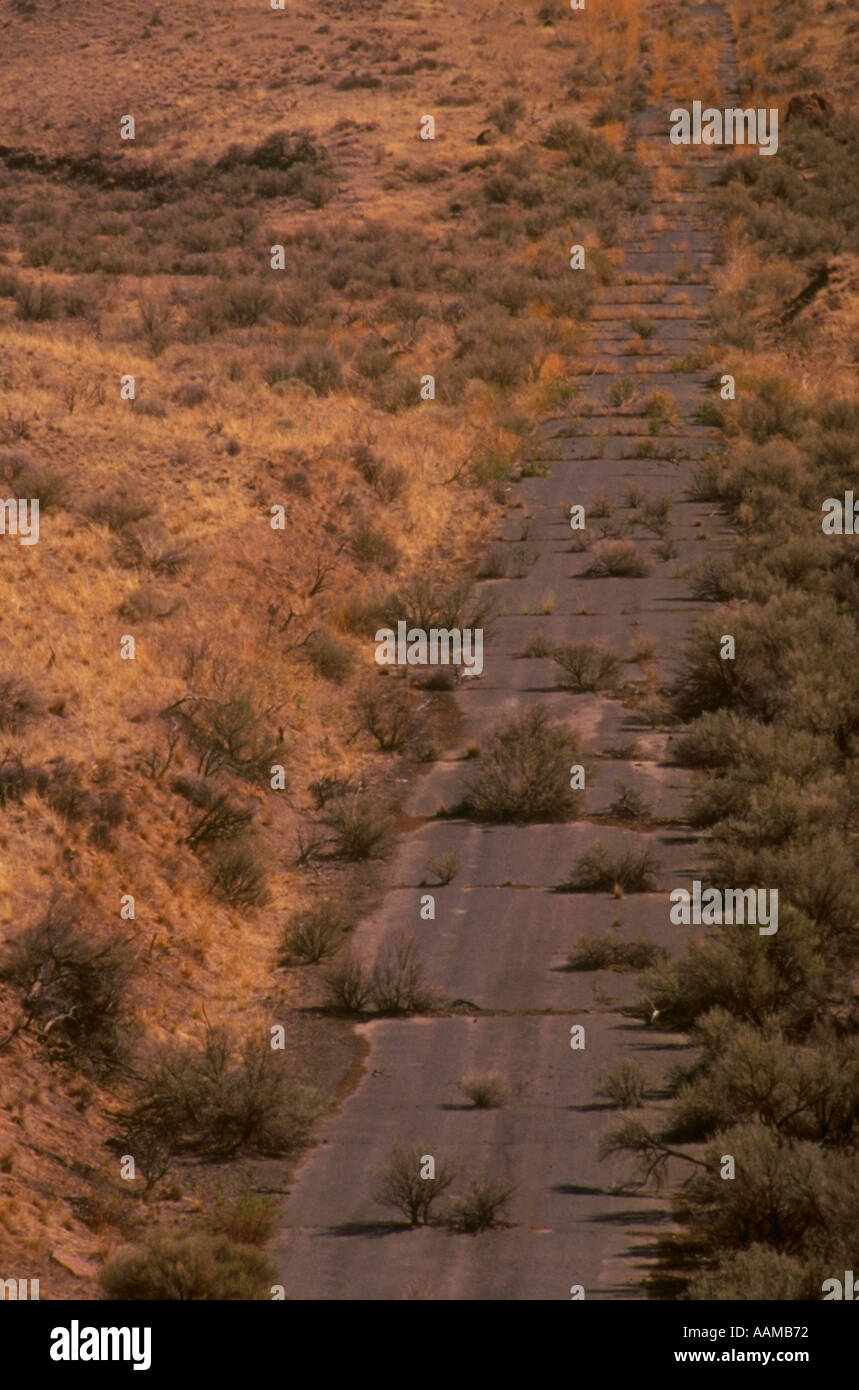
[597, 0, 859, 1300]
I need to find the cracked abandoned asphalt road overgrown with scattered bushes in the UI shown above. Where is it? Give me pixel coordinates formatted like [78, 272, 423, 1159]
[272, 6, 737, 1300]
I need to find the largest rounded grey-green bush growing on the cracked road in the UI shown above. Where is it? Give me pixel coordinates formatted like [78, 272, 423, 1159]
[461, 706, 581, 823]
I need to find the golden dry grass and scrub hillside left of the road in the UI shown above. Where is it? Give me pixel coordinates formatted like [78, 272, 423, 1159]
[0, 0, 642, 1298]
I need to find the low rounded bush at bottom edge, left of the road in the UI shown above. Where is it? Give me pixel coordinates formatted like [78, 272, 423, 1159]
[100, 1234, 277, 1302]
